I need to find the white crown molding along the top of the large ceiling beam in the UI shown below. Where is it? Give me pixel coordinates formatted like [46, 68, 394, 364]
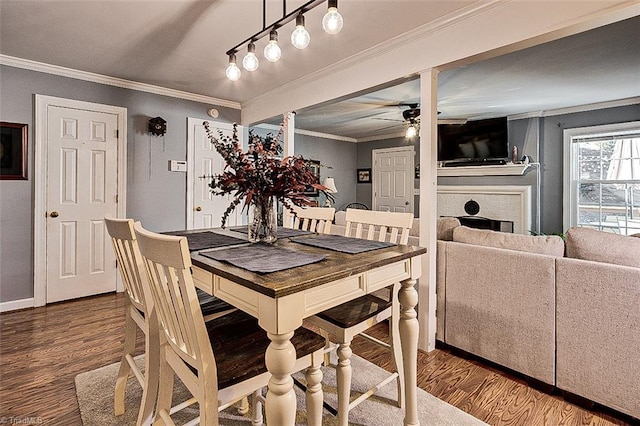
[242, 0, 503, 113]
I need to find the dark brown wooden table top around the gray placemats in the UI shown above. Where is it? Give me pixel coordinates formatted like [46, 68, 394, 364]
[191, 228, 427, 298]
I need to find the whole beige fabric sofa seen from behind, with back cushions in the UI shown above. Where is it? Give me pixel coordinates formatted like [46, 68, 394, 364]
[436, 223, 640, 418]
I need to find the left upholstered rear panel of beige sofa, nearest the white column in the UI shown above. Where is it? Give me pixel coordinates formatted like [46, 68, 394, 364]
[445, 242, 556, 385]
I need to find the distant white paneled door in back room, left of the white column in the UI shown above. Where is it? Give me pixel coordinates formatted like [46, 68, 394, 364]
[372, 147, 414, 213]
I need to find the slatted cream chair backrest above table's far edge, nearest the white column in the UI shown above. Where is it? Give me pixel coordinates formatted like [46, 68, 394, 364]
[344, 209, 413, 244]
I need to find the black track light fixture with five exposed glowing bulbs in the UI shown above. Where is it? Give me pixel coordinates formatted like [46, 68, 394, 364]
[226, 0, 343, 81]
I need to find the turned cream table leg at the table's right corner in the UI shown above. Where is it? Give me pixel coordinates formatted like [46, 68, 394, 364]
[398, 279, 420, 426]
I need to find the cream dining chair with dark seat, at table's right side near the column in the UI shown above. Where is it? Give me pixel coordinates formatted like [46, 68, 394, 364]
[307, 209, 413, 426]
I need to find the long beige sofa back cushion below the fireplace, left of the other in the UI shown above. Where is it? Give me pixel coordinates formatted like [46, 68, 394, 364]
[453, 226, 564, 257]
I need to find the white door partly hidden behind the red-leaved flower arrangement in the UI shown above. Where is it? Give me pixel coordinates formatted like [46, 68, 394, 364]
[186, 118, 243, 229]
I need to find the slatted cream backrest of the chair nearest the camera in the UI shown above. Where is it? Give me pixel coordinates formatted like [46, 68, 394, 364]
[134, 223, 216, 376]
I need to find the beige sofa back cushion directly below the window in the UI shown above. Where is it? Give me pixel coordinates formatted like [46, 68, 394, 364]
[566, 227, 640, 268]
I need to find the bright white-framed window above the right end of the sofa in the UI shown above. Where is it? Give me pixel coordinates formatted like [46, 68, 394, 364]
[564, 122, 640, 235]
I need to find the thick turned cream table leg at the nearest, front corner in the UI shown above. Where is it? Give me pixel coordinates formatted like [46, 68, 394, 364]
[265, 331, 296, 426]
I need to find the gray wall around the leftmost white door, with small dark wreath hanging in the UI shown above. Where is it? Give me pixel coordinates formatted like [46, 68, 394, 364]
[0, 66, 240, 302]
